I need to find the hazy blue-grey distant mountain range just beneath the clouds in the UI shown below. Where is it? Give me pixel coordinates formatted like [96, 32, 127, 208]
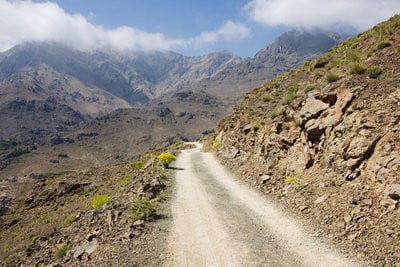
[0, 30, 346, 108]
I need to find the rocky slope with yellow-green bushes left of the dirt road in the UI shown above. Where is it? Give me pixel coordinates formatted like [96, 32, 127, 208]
[0, 144, 189, 266]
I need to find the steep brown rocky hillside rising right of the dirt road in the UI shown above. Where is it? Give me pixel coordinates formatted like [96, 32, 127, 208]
[214, 15, 400, 266]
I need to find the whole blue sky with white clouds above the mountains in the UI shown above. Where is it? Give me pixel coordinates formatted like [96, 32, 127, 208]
[0, 0, 400, 57]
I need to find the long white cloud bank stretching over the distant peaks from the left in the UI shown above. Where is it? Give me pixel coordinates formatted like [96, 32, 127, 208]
[0, 0, 250, 51]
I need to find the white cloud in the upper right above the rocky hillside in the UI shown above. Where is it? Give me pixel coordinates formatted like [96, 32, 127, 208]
[245, 0, 400, 30]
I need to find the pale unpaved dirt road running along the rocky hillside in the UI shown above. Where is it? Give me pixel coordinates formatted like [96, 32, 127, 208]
[169, 144, 354, 266]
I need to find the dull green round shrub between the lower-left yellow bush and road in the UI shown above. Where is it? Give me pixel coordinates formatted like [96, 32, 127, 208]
[130, 197, 157, 222]
